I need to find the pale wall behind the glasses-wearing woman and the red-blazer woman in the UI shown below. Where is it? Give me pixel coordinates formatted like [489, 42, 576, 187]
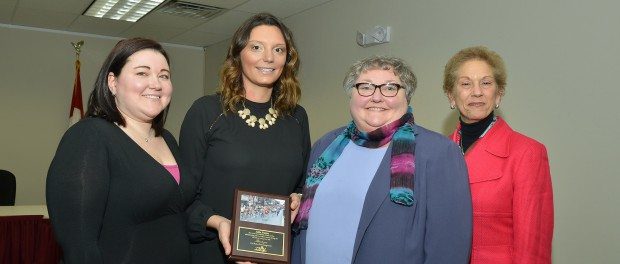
[201, 0, 620, 263]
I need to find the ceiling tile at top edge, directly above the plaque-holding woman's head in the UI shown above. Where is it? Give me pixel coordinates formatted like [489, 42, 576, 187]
[235, 0, 332, 18]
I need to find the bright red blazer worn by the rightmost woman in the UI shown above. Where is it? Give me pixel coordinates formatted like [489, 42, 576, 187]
[451, 117, 553, 264]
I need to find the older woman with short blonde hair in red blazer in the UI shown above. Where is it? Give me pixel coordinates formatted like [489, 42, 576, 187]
[443, 47, 553, 264]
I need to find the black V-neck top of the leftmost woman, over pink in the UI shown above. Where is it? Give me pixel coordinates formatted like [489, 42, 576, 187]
[46, 118, 196, 263]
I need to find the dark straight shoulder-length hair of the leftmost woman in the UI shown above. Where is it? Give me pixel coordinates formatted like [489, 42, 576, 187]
[86, 38, 170, 136]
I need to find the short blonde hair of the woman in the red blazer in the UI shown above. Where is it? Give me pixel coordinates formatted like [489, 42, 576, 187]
[443, 46, 507, 95]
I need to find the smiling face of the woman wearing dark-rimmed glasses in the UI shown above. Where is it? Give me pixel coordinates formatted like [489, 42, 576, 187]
[349, 69, 408, 133]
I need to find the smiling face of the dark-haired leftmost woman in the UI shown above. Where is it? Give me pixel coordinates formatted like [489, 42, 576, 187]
[108, 49, 172, 122]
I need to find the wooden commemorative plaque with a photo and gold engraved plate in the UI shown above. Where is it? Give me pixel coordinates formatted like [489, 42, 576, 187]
[229, 190, 291, 264]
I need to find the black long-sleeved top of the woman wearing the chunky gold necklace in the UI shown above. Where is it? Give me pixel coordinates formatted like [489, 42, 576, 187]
[179, 95, 310, 263]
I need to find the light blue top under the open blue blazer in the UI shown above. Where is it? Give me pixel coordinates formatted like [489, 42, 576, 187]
[306, 141, 387, 264]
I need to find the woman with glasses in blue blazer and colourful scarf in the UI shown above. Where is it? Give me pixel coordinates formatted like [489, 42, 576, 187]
[291, 57, 472, 264]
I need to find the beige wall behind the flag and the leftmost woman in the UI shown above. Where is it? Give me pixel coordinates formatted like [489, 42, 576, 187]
[0, 25, 204, 205]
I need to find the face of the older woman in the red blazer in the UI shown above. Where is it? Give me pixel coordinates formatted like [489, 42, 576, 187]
[448, 60, 502, 124]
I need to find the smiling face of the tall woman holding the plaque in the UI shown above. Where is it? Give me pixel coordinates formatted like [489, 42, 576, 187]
[241, 25, 287, 89]
